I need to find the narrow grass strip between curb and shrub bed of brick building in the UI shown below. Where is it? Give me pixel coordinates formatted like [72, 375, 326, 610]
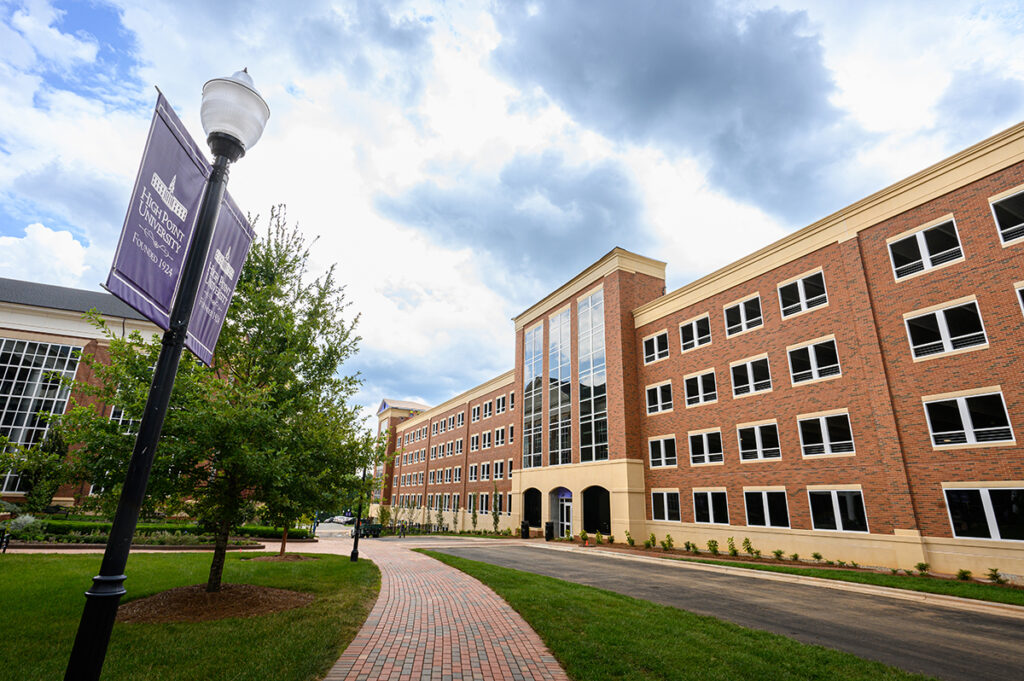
[655, 556, 1024, 605]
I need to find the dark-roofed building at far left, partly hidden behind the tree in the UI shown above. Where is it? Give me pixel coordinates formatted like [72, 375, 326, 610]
[0, 279, 160, 505]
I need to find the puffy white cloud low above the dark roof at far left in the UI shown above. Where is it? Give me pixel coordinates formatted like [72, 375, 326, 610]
[0, 222, 95, 289]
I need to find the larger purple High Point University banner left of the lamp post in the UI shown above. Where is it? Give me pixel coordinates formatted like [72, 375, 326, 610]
[105, 93, 210, 331]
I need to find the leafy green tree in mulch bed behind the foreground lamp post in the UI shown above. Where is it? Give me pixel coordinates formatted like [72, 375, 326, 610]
[60, 207, 364, 592]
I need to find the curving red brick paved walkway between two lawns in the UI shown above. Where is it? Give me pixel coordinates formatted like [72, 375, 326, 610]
[326, 542, 568, 681]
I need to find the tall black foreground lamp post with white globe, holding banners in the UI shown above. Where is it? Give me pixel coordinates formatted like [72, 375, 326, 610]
[65, 71, 270, 681]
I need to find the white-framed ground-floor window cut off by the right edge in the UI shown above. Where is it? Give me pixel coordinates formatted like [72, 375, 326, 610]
[945, 487, 1024, 542]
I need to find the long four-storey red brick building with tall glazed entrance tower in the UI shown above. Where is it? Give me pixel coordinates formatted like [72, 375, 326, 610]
[381, 119, 1024, 576]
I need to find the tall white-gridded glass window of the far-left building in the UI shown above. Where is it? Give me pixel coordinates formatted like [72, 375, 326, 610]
[0, 338, 82, 493]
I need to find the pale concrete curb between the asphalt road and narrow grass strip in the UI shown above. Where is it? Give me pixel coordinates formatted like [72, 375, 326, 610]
[538, 544, 1024, 620]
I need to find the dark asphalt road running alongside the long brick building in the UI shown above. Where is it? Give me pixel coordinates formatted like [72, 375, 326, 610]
[417, 541, 1024, 681]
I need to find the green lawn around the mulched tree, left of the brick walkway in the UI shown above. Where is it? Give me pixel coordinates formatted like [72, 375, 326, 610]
[0, 553, 380, 681]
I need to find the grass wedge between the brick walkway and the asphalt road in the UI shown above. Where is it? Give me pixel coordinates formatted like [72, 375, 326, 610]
[423, 551, 929, 681]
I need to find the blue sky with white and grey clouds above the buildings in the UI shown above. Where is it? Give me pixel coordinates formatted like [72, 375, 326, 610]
[0, 0, 1024, 421]
